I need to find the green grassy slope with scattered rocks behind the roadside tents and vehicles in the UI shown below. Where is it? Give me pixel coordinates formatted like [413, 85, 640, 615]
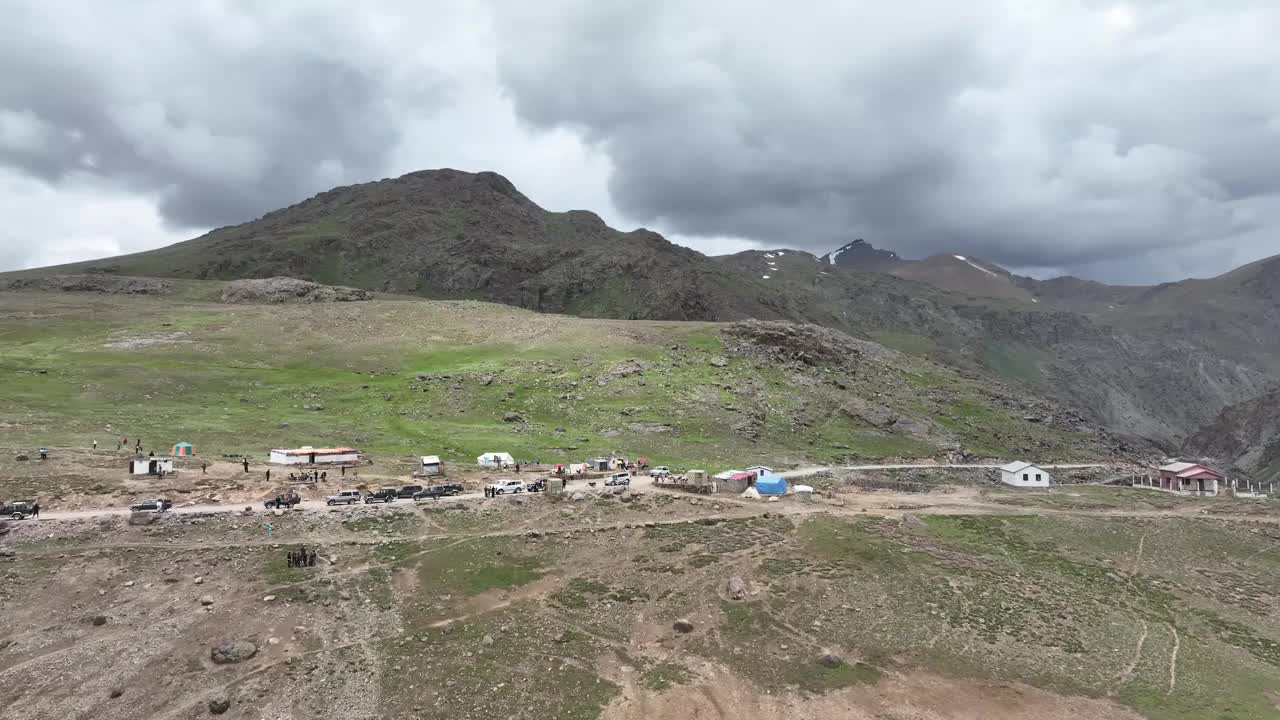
[0, 283, 1120, 469]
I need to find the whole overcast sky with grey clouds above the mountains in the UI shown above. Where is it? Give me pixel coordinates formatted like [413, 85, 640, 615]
[0, 0, 1280, 283]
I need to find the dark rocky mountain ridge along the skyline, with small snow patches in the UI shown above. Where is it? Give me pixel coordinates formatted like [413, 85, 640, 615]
[10, 169, 1280, 455]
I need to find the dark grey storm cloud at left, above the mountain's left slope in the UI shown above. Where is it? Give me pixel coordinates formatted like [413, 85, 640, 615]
[0, 1, 440, 227]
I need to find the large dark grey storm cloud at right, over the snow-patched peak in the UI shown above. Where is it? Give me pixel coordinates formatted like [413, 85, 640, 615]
[499, 0, 1280, 275]
